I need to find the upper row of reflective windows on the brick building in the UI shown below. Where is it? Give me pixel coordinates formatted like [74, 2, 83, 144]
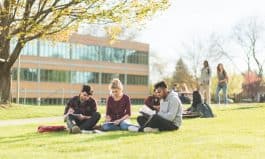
[10, 39, 148, 65]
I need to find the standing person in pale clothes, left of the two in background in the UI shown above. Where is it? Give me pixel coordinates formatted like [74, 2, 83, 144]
[200, 60, 212, 105]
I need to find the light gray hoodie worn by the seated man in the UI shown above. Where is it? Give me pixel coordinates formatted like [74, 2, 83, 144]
[158, 91, 182, 127]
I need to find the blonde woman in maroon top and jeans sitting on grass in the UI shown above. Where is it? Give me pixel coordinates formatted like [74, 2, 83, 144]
[102, 79, 134, 131]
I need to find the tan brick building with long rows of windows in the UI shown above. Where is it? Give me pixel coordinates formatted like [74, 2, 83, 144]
[11, 34, 149, 104]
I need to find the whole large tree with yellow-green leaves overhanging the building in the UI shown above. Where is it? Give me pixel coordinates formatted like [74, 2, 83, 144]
[0, 0, 169, 103]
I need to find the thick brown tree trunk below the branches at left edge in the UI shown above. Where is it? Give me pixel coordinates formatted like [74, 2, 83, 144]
[0, 65, 11, 104]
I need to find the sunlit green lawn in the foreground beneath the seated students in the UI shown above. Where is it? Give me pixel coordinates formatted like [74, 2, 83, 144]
[0, 104, 265, 159]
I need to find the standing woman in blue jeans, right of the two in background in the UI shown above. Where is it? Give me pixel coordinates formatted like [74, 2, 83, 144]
[215, 63, 228, 104]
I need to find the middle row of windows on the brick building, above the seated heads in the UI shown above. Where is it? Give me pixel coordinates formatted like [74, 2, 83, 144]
[12, 68, 148, 85]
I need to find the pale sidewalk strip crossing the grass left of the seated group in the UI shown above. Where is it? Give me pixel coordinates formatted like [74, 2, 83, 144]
[0, 116, 63, 127]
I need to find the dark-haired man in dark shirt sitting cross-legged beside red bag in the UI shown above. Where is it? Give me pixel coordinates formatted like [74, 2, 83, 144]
[64, 85, 100, 133]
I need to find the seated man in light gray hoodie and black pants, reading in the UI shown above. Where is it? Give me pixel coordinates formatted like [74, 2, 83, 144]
[136, 81, 182, 132]
